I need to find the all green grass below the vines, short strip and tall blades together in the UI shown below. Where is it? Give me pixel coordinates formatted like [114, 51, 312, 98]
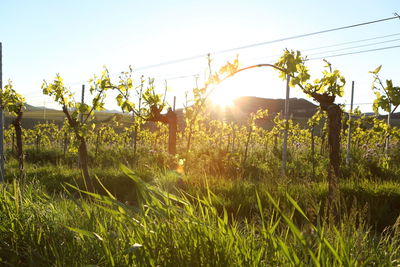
[0, 142, 400, 266]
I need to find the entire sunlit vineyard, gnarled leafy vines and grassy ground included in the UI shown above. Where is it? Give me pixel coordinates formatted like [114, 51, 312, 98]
[0, 50, 400, 266]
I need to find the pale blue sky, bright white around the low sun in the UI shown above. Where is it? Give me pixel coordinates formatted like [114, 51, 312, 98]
[0, 0, 400, 112]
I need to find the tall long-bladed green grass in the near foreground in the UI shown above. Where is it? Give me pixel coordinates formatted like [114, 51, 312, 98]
[0, 168, 400, 266]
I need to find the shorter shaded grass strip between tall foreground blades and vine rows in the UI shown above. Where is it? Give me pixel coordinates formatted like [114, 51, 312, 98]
[7, 150, 400, 231]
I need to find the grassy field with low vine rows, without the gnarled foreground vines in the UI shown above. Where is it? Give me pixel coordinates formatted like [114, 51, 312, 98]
[0, 101, 400, 266]
